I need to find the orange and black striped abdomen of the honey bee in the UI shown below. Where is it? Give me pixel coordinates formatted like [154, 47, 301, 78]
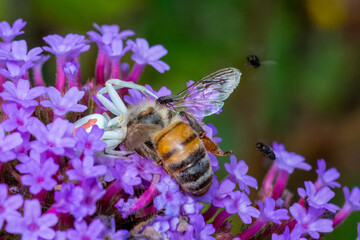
[155, 121, 212, 195]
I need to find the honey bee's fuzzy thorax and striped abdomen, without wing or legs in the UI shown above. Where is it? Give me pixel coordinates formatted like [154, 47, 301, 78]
[123, 101, 212, 196]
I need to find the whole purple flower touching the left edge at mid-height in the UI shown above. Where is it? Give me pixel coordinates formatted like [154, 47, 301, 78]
[2, 102, 35, 132]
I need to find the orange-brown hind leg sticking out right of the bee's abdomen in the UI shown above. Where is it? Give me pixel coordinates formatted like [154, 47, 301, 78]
[180, 111, 232, 156]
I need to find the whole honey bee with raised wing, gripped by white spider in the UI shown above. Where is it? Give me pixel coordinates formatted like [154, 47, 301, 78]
[122, 68, 241, 196]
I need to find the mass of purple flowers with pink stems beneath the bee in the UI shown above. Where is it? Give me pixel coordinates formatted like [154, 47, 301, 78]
[0, 19, 360, 240]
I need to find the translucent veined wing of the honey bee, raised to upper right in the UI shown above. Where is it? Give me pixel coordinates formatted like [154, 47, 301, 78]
[168, 68, 241, 117]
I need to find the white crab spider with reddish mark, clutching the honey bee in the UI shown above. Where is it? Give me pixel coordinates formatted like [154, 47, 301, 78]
[75, 79, 158, 156]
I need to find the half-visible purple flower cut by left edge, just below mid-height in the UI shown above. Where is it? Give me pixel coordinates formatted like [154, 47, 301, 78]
[0, 124, 23, 162]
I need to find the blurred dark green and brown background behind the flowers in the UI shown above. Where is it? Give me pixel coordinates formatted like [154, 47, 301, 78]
[0, 0, 360, 239]
